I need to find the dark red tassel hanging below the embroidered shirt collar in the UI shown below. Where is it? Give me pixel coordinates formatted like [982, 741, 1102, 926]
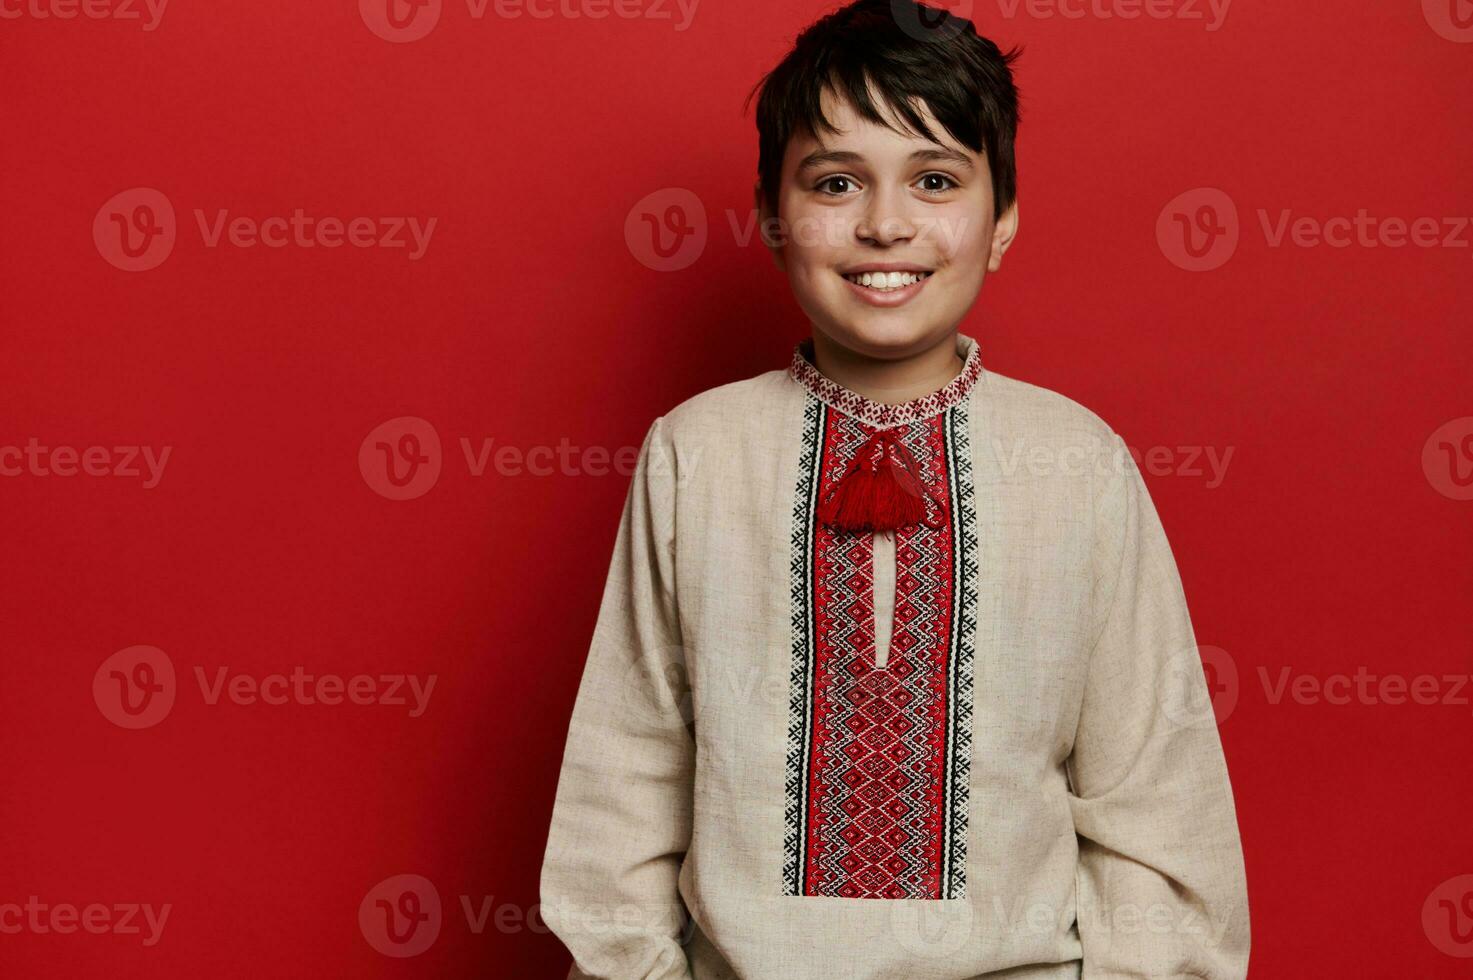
[819, 429, 931, 532]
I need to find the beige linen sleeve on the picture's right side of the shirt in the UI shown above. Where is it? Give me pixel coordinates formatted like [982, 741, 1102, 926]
[1066, 435, 1249, 980]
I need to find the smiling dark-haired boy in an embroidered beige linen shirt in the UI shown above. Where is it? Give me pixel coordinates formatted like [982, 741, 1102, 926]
[542, 0, 1249, 980]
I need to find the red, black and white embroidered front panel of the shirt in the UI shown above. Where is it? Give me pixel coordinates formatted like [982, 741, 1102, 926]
[784, 345, 977, 899]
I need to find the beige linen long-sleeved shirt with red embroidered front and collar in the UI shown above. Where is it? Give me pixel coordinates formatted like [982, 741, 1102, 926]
[541, 335, 1249, 980]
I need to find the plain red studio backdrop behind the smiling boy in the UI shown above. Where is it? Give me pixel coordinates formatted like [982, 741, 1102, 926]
[0, 0, 1473, 980]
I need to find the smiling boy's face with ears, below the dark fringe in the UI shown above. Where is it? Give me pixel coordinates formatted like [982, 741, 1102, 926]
[757, 90, 1018, 360]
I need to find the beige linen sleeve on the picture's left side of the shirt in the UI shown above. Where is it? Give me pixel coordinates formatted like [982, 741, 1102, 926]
[541, 419, 695, 980]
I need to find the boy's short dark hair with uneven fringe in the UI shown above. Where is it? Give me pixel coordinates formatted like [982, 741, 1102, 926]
[747, 0, 1021, 217]
